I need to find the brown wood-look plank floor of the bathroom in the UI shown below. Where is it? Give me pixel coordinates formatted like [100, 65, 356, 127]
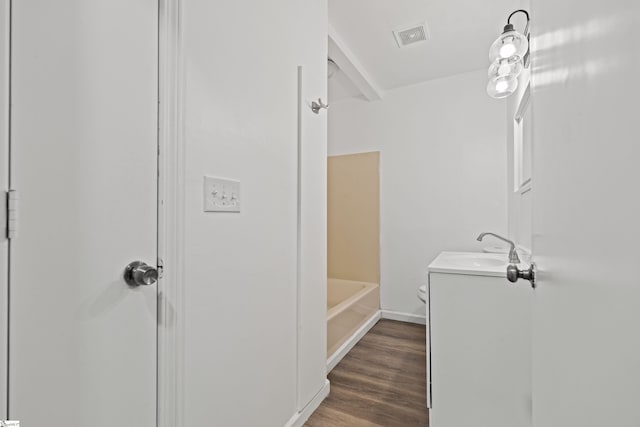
[305, 320, 429, 427]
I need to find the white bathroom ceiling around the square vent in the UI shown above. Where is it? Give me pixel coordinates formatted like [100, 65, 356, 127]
[329, 0, 524, 100]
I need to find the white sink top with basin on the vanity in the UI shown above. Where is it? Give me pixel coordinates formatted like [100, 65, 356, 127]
[429, 252, 509, 277]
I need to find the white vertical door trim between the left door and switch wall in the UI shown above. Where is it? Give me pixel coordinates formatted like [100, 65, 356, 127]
[157, 0, 185, 427]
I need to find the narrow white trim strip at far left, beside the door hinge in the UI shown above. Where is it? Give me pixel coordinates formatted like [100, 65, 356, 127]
[0, 0, 11, 420]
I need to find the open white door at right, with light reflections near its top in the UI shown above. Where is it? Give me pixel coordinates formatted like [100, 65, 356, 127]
[532, 0, 640, 427]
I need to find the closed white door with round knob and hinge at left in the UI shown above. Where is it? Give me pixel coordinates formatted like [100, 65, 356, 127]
[9, 0, 158, 427]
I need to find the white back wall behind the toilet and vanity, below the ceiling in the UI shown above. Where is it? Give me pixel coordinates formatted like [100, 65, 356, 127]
[329, 70, 507, 315]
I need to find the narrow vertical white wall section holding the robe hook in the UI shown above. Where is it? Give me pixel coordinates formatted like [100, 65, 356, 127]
[290, 0, 328, 413]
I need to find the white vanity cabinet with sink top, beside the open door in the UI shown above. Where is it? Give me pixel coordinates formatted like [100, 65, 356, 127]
[427, 252, 532, 427]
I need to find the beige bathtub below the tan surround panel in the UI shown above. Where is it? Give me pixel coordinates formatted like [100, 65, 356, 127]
[327, 278, 380, 359]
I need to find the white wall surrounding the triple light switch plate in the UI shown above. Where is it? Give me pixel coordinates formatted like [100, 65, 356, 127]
[183, 0, 327, 427]
